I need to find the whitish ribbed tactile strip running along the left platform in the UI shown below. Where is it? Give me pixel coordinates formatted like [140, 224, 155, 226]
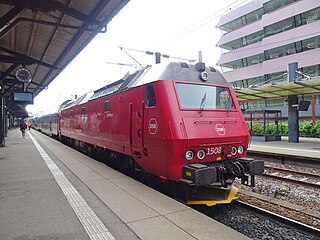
[28, 132, 115, 240]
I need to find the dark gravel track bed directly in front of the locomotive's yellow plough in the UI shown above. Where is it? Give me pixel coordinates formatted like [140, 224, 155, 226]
[193, 201, 320, 240]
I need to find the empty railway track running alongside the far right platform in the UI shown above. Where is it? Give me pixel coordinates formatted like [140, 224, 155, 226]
[263, 165, 320, 189]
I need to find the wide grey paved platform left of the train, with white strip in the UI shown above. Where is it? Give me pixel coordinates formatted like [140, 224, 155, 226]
[0, 129, 248, 240]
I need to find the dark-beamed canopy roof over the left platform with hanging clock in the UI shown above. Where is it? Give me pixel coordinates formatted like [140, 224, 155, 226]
[0, 0, 129, 116]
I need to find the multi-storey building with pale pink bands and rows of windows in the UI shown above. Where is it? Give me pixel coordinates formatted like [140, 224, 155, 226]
[218, 0, 320, 110]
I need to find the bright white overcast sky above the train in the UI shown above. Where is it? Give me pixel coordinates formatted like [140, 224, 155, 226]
[26, 0, 249, 115]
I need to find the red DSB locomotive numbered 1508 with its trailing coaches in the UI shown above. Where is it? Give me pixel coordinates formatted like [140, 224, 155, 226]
[33, 62, 264, 206]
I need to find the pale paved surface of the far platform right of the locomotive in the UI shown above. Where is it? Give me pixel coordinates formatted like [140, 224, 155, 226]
[248, 137, 320, 159]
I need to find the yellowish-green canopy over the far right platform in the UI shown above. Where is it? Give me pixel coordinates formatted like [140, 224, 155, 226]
[235, 76, 320, 102]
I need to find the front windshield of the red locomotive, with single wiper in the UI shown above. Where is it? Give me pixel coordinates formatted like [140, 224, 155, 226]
[176, 83, 235, 111]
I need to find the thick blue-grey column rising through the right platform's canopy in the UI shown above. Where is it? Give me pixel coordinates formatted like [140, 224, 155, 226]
[287, 62, 299, 143]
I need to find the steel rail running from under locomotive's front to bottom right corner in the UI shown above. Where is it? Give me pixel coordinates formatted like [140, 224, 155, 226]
[234, 200, 320, 238]
